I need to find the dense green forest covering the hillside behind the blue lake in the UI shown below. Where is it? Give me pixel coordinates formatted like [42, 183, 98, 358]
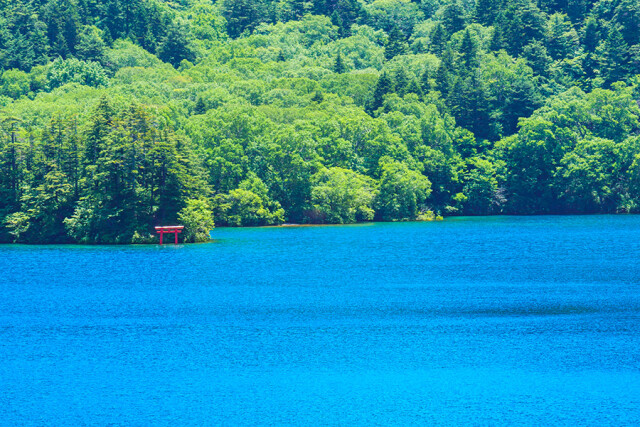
[0, 0, 640, 243]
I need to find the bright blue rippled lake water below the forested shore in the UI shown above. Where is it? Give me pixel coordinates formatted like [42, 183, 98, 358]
[0, 216, 640, 426]
